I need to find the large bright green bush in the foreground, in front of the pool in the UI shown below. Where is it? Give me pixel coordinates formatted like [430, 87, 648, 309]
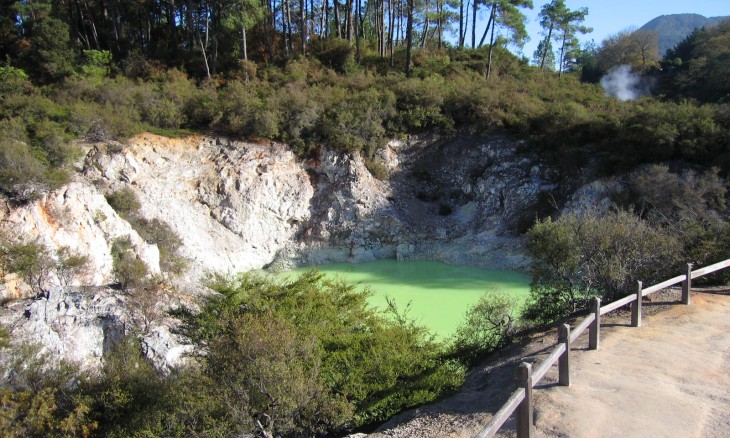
[173, 272, 464, 436]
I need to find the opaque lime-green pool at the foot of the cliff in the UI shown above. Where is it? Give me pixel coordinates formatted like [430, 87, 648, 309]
[285, 260, 530, 339]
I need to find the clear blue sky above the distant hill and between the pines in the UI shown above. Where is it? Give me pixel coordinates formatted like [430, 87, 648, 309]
[510, 0, 730, 59]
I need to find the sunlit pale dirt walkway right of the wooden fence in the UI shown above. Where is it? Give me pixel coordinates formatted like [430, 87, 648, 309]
[535, 293, 730, 437]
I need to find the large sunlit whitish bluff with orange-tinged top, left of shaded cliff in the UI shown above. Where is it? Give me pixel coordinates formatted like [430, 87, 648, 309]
[85, 134, 314, 280]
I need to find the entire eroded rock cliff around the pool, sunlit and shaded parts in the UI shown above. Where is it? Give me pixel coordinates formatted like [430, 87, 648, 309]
[0, 134, 554, 369]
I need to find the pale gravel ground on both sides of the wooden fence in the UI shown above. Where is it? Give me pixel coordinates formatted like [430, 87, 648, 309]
[370, 289, 730, 438]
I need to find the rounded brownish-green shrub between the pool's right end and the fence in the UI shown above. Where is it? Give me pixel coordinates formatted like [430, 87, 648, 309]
[524, 210, 681, 324]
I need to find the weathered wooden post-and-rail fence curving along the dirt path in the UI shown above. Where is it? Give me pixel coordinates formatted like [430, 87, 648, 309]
[477, 259, 730, 438]
